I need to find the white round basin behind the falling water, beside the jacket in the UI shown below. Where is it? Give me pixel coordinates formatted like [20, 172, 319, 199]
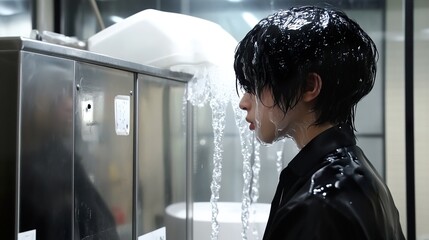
[165, 202, 270, 240]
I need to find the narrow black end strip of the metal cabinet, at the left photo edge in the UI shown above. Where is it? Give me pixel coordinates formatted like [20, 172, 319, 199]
[0, 51, 19, 239]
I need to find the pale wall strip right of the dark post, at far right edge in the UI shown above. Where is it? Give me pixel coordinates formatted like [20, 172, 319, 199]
[414, 0, 429, 237]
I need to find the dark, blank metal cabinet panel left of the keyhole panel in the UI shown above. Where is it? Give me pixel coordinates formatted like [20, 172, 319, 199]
[18, 52, 74, 240]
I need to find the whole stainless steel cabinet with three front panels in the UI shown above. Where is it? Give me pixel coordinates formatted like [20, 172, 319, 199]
[0, 38, 190, 240]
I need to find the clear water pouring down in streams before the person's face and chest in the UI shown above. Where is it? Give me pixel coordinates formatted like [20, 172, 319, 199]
[184, 57, 270, 240]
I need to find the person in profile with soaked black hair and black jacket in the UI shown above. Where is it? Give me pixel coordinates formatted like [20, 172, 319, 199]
[234, 6, 405, 240]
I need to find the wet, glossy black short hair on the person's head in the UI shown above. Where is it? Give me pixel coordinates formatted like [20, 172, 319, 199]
[234, 6, 378, 128]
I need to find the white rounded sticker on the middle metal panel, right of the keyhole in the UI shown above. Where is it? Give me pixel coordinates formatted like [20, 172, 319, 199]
[115, 95, 131, 136]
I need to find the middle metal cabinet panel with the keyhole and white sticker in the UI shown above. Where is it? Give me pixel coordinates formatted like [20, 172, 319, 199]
[74, 63, 134, 240]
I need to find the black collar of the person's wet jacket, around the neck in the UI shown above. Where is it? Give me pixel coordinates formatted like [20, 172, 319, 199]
[287, 124, 356, 176]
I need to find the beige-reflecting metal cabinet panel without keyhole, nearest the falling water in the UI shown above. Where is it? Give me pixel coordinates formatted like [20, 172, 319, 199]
[137, 75, 187, 240]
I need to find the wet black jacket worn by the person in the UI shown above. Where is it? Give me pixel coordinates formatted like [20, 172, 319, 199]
[263, 125, 405, 240]
